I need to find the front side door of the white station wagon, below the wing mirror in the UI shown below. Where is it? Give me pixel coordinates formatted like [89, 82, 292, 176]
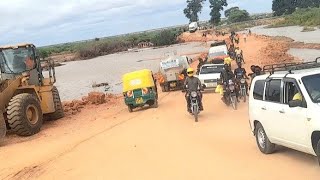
[278, 78, 308, 152]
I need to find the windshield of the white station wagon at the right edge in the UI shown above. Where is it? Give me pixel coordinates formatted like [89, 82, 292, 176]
[302, 74, 320, 103]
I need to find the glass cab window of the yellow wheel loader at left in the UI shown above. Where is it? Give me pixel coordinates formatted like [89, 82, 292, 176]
[0, 47, 35, 74]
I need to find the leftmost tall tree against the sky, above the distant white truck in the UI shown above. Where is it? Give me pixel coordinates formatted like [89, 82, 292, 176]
[183, 0, 206, 22]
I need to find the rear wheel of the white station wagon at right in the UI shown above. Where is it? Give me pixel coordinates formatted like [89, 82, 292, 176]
[255, 123, 275, 154]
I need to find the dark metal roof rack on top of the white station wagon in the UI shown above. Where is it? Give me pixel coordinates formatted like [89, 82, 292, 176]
[262, 57, 320, 74]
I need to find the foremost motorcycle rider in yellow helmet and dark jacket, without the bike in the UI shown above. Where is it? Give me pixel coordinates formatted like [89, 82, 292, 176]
[184, 68, 203, 113]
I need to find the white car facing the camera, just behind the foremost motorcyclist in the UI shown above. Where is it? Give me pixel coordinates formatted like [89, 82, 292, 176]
[198, 64, 224, 89]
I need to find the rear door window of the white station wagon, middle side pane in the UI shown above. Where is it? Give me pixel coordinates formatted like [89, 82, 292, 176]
[266, 79, 281, 103]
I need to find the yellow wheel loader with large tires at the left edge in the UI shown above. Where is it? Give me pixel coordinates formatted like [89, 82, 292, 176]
[0, 44, 64, 141]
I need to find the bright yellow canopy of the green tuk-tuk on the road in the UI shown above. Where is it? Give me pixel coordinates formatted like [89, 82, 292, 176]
[122, 69, 155, 92]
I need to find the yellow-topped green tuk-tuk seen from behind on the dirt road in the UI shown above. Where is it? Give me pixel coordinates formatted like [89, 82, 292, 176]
[122, 69, 158, 112]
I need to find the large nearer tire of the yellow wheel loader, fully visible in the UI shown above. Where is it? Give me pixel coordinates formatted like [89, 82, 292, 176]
[7, 93, 43, 136]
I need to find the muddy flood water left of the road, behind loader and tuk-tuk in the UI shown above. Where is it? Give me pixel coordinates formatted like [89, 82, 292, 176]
[56, 43, 207, 101]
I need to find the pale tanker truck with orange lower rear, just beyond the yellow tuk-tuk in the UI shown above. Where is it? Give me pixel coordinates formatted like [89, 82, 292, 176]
[159, 56, 190, 92]
